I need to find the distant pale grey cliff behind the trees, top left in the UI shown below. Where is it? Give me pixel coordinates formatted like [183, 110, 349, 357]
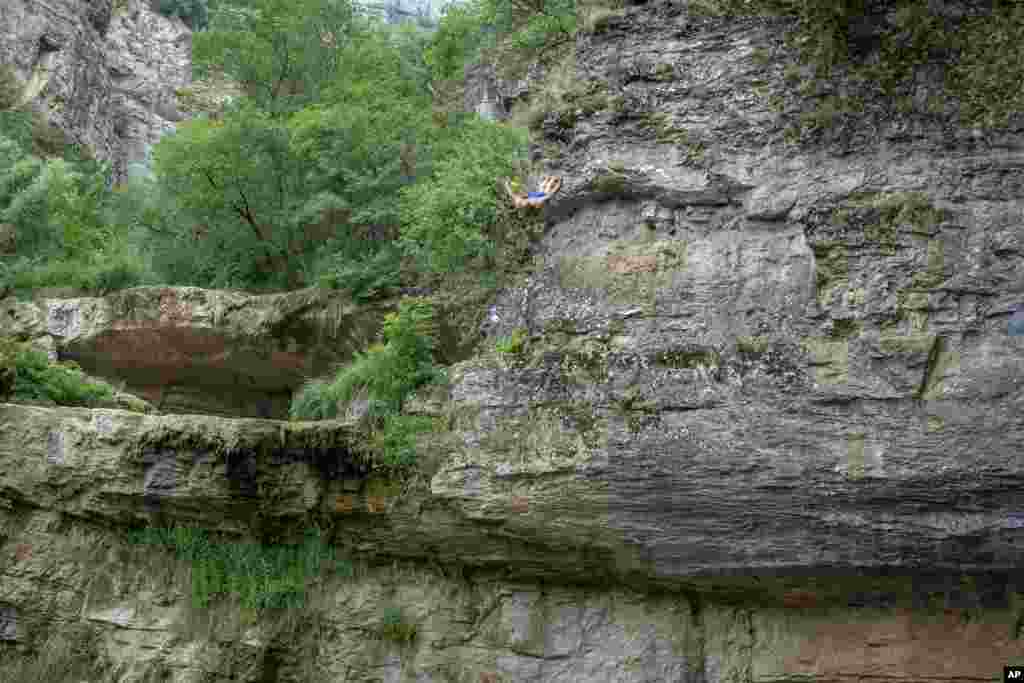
[0, 0, 191, 181]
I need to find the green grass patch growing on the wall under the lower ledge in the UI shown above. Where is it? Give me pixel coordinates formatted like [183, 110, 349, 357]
[129, 526, 352, 610]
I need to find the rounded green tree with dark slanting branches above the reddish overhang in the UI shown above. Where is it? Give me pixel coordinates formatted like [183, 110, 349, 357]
[154, 108, 309, 288]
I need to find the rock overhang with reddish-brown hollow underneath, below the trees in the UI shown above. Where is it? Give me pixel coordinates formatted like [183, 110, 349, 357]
[0, 287, 389, 418]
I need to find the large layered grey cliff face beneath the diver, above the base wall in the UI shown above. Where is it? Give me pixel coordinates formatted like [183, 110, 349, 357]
[456, 0, 1024, 578]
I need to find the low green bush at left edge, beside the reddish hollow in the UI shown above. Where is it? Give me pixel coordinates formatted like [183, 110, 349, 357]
[0, 338, 114, 407]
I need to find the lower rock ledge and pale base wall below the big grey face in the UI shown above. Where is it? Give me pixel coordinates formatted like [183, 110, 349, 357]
[0, 405, 1024, 683]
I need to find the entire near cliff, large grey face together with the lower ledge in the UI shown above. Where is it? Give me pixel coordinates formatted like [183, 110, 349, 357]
[0, 5, 1024, 683]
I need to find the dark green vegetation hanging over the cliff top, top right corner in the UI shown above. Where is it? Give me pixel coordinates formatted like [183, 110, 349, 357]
[695, 0, 1024, 132]
